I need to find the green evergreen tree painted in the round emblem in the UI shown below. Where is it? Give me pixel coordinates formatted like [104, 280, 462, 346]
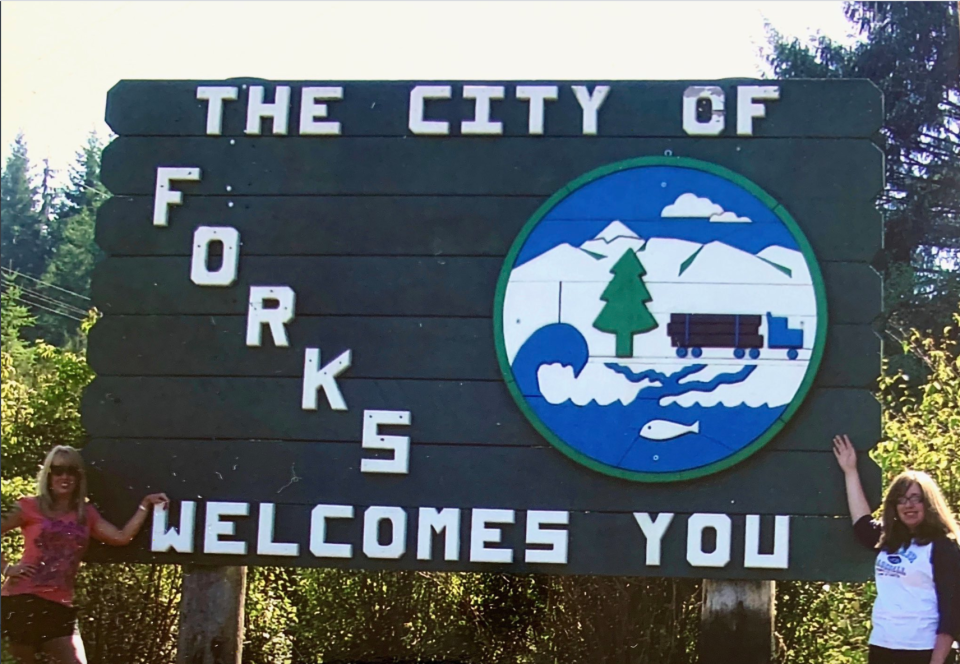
[593, 249, 657, 357]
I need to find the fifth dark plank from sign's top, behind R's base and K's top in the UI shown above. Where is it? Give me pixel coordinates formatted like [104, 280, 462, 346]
[89, 315, 880, 388]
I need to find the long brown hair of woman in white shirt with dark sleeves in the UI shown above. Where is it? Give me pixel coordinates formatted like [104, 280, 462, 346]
[877, 470, 960, 553]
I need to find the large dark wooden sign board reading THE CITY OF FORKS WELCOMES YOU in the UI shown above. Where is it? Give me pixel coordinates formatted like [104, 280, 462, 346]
[83, 79, 883, 660]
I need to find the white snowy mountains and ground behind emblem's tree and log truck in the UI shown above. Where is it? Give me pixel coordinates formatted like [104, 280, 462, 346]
[503, 221, 817, 405]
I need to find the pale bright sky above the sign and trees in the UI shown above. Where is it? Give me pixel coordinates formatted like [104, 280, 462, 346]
[0, 0, 851, 176]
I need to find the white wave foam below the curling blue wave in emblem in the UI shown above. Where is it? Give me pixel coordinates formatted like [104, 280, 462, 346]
[537, 362, 660, 406]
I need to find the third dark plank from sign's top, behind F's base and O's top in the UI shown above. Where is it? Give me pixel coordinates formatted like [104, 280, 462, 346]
[97, 195, 882, 262]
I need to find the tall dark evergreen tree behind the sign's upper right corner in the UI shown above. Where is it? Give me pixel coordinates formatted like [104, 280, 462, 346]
[767, 2, 960, 341]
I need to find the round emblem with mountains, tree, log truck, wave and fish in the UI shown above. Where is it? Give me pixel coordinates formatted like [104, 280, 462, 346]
[494, 157, 826, 481]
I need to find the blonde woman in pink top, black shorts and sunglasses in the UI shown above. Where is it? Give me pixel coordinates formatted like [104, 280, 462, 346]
[0, 445, 168, 664]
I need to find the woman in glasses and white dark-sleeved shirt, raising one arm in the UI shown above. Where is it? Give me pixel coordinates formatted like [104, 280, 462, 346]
[833, 435, 960, 664]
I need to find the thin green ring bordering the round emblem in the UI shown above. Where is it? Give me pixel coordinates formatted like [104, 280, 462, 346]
[493, 157, 827, 482]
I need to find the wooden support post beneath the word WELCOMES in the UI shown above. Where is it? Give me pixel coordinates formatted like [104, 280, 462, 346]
[177, 565, 247, 664]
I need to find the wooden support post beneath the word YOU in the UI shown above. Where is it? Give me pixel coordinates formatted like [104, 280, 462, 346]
[699, 579, 776, 664]
